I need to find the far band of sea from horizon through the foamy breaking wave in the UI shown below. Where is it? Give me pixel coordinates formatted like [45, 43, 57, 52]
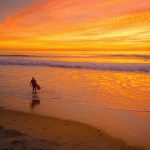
[0, 51, 150, 72]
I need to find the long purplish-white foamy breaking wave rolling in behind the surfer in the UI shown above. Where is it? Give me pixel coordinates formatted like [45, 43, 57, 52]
[0, 58, 150, 72]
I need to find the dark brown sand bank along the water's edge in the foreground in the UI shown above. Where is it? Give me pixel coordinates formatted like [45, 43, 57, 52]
[0, 107, 144, 150]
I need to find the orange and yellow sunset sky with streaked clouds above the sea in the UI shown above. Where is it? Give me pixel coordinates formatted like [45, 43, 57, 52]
[0, 0, 150, 51]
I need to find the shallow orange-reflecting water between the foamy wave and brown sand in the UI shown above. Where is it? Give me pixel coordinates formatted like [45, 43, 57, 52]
[0, 65, 150, 148]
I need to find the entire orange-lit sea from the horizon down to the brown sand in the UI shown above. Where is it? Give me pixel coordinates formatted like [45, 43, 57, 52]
[0, 51, 150, 148]
